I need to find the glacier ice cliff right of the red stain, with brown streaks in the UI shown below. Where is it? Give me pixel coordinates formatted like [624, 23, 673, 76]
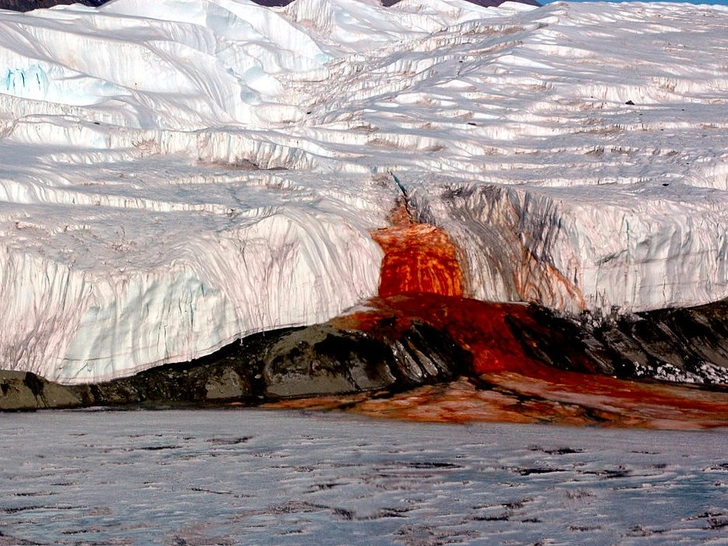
[413, 179, 728, 313]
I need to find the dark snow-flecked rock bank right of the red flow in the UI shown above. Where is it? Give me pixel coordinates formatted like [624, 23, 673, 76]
[484, 300, 728, 386]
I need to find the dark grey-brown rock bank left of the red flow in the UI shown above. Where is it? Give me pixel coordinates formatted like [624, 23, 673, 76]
[0, 314, 471, 410]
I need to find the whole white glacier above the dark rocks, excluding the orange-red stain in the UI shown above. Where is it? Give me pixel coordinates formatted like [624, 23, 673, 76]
[0, 0, 728, 384]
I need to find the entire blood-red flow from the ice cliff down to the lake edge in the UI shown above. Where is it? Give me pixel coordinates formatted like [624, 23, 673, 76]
[272, 205, 728, 429]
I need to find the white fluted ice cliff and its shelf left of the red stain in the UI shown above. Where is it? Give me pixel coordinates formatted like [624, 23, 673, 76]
[0, 146, 394, 383]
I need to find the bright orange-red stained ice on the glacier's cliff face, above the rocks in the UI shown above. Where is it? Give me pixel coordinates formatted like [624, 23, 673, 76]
[372, 203, 463, 297]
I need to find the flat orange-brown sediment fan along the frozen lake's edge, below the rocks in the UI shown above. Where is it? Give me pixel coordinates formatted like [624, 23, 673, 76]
[328, 374, 728, 430]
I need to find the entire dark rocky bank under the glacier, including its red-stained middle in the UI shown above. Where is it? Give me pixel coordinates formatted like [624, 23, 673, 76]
[0, 294, 728, 410]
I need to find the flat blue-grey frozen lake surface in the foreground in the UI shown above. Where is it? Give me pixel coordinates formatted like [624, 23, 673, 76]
[0, 409, 728, 546]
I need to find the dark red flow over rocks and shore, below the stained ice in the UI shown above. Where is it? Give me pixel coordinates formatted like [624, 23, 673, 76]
[328, 294, 728, 429]
